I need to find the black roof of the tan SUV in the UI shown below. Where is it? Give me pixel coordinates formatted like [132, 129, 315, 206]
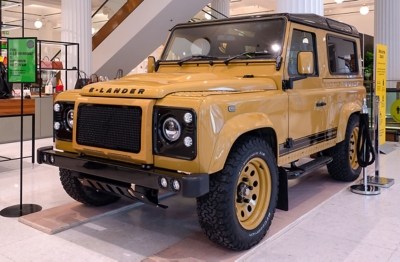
[174, 13, 360, 38]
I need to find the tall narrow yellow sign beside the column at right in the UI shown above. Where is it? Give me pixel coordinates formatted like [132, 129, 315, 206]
[375, 44, 387, 145]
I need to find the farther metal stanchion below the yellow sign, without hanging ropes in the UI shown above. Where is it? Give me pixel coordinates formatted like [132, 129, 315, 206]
[368, 96, 394, 188]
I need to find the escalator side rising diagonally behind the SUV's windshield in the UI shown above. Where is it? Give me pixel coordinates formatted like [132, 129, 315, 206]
[92, 0, 210, 78]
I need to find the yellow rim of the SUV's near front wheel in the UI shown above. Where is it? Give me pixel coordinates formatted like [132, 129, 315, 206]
[235, 158, 271, 230]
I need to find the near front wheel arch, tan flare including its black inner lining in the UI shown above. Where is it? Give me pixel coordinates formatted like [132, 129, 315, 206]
[208, 113, 278, 174]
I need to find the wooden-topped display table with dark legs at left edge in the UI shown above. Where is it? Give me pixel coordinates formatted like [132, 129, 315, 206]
[0, 98, 35, 163]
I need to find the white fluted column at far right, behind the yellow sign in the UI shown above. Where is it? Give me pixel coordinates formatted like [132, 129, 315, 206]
[374, 0, 400, 113]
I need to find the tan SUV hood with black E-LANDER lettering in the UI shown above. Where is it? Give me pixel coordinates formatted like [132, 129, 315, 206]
[80, 73, 276, 98]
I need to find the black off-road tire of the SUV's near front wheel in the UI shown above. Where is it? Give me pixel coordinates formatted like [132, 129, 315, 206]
[197, 137, 279, 250]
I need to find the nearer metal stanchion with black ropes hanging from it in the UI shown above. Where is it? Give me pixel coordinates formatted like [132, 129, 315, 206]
[350, 98, 381, 195]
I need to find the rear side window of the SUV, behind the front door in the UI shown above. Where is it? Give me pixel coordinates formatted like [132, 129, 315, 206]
[327, 35, 358, 75]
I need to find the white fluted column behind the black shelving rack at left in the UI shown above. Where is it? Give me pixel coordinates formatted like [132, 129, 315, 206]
[61, 0, 92, 89]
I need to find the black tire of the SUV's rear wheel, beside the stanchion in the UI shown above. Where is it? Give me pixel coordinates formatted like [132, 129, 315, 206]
[327, 114, 361, 182]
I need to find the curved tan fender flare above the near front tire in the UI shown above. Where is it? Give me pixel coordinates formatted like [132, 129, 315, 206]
[207, 113, 273, 174]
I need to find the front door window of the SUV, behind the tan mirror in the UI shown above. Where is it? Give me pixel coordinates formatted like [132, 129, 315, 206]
[288, 29, 318, 76]
